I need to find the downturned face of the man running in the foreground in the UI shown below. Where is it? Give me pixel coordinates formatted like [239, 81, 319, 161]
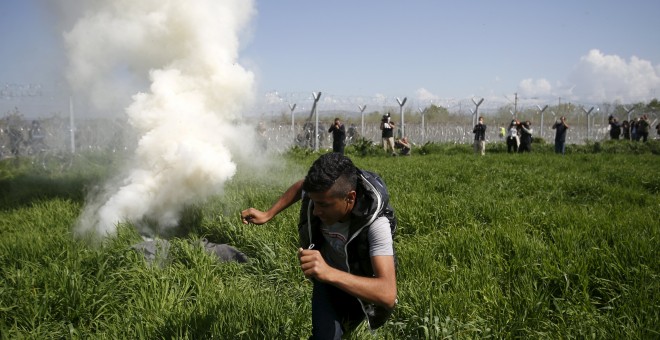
[309, 188, 355, 225]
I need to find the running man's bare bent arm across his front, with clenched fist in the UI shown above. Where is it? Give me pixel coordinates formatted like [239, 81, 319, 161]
[298, 248, 396, 309]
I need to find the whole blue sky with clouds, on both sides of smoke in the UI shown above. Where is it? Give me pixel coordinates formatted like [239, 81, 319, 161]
[0, 0, 660, 117]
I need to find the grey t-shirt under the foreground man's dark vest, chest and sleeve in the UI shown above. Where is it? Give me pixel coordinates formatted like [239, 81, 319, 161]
[321, 217, 394, 271]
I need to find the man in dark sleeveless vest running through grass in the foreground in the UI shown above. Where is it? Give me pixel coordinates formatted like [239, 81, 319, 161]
[241, 153, 397, 339]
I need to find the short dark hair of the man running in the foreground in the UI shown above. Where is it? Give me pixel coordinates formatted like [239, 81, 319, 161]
[303, 152, 357, 197]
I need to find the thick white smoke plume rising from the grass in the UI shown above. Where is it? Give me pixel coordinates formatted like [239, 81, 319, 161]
[65, 0, 255, 236]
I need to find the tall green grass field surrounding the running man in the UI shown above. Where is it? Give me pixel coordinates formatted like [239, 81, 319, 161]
[0, 144, 660, 339]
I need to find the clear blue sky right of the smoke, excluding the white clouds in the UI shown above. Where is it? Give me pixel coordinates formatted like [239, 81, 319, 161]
[244, 0, 660, 105]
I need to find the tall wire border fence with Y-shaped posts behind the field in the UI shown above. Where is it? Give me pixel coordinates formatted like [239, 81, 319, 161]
[0, 85, 658, 159]
